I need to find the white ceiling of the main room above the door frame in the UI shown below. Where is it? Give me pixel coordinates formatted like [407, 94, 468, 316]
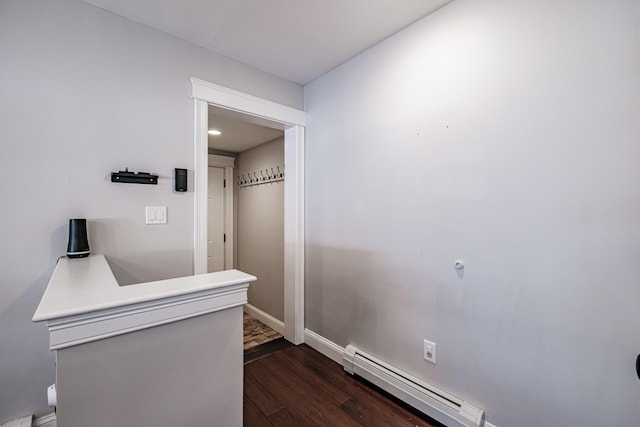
[79, 0, 453, 85]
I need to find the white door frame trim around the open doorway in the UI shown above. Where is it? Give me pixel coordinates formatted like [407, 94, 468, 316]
[191, 77, 305, 344]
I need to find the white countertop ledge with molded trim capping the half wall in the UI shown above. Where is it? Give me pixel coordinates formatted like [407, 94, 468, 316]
[33, 255, 256, 350]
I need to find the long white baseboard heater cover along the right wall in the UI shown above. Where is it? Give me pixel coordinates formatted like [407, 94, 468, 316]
[342, 345, 484, 427]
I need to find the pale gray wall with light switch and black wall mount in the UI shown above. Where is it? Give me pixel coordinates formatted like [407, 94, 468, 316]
[0, 0, 303, 423]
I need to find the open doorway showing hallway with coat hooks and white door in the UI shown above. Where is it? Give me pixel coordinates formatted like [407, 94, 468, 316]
[207, 105, 284, 339]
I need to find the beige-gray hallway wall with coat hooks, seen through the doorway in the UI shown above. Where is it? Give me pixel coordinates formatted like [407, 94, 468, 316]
[236, 137, 284, 321]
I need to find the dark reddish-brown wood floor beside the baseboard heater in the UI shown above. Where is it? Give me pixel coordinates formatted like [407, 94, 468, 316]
[244, 344, 442, 427]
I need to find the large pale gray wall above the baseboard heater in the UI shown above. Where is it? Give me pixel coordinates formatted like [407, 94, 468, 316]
[305, 0, 640, 427]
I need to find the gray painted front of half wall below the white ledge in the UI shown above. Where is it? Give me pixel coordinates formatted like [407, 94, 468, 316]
[56, 307, 243, 427]
